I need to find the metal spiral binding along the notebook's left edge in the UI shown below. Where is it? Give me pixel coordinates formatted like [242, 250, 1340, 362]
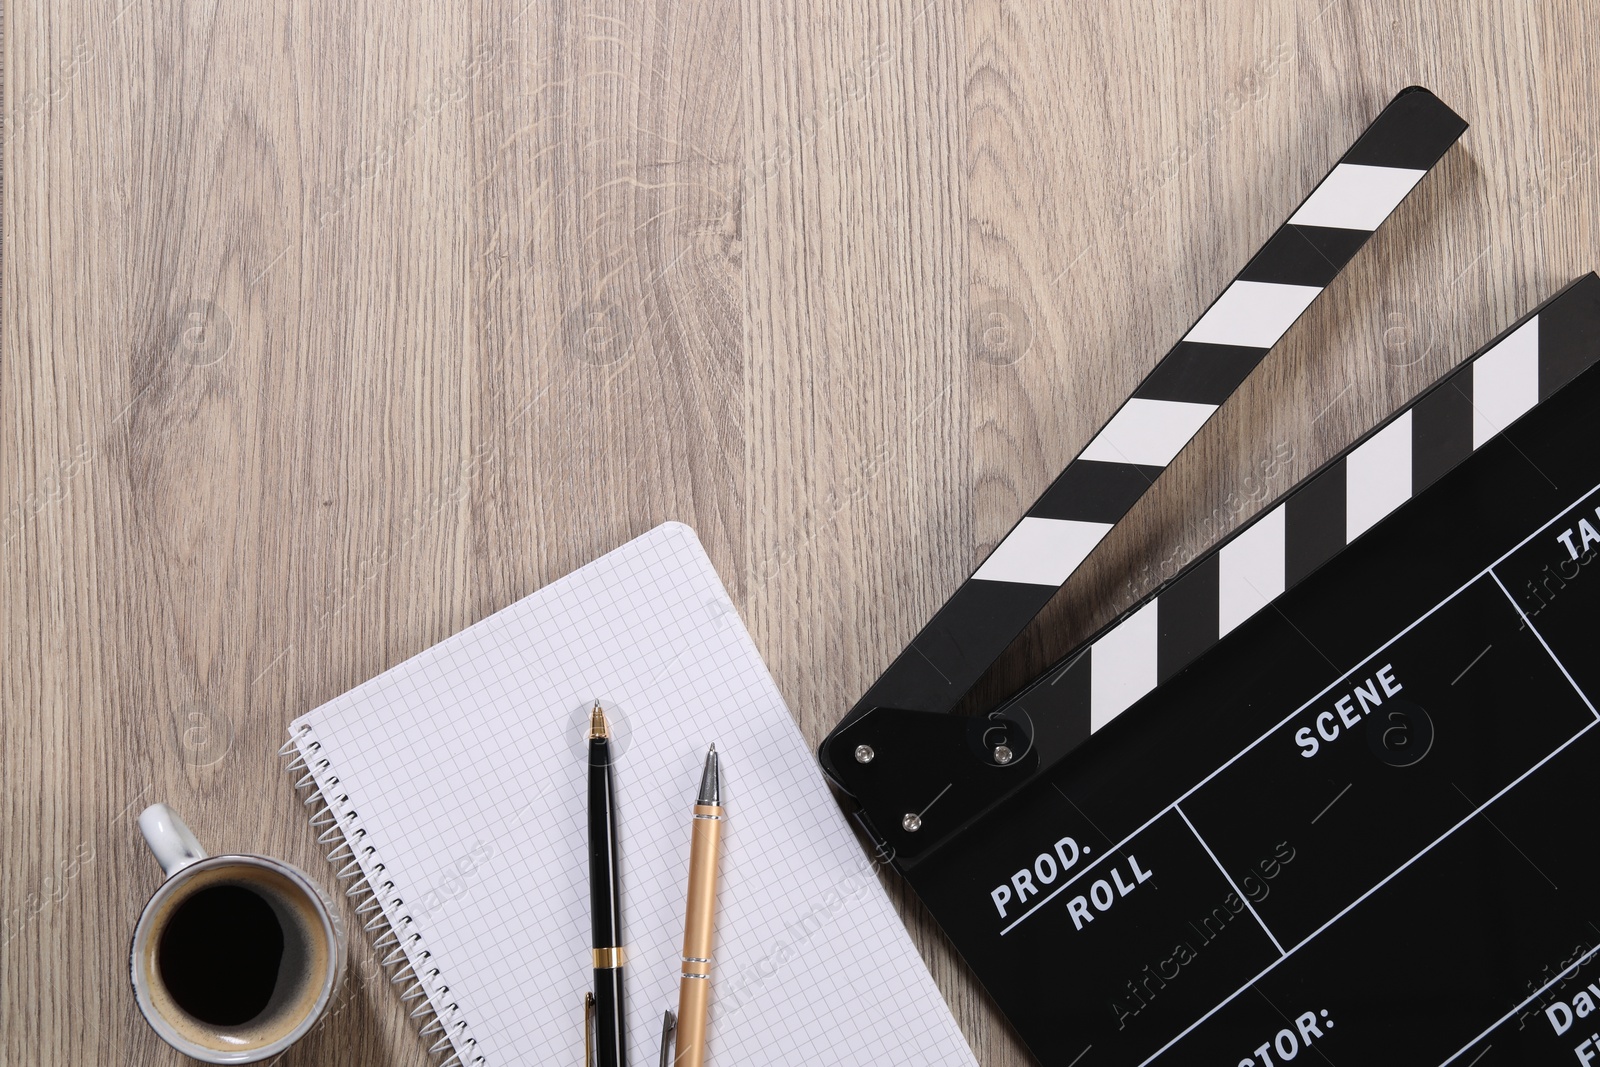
[278, 723, 488, 1067]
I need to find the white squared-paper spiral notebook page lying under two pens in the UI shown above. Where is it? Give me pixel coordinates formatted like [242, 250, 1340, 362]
[285, 523, 974, 1067]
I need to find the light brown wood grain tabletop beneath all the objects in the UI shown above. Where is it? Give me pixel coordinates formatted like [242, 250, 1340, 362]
[0, 0, 1600, 1065]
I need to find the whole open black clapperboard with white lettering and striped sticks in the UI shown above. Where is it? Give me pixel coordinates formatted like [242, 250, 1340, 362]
[821, 88, 1600, 1067]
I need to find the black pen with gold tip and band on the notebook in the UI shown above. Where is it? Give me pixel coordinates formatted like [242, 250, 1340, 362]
[589, 704, 627, 1067]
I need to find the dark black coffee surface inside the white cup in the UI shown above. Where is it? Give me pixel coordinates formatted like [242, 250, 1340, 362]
[155, 885, 283, 1025]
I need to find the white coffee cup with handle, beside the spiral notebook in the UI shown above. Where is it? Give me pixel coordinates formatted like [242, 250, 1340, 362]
[128, 805, 346, 1064]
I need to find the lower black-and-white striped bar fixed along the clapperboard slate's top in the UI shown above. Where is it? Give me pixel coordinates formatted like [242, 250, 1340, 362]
[1029, 274, 1600, 739]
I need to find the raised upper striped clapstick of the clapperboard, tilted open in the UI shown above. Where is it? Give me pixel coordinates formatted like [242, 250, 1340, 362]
[845, 86, 1467, 723]
